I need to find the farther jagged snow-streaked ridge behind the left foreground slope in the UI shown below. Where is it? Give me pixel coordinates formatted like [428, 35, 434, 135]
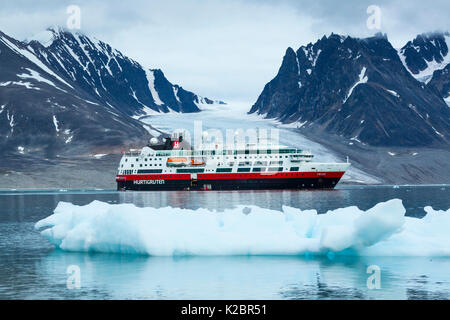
[28, 28, 220, 116]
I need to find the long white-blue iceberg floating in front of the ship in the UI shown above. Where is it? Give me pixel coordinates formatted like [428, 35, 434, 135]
[35, 199, 450, 257]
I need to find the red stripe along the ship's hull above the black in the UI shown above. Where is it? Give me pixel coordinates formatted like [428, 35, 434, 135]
[116, 172, 345, 181]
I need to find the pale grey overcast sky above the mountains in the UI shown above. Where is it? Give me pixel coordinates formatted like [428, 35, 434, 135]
[0, 0, 450, 103]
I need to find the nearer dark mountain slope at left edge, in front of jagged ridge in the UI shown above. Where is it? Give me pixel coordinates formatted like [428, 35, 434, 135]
[0, 29, 147, 157]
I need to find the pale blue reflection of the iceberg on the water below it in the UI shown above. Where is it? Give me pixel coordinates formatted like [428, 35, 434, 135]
[0, 250, 442, 299]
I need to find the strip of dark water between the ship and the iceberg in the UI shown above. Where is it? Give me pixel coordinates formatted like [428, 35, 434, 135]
[0, 186, 450, 223]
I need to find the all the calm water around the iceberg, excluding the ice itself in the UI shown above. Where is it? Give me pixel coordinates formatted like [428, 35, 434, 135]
[0, 186, 450, 299]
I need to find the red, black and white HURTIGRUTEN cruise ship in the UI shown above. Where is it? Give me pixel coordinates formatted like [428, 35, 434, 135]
[116, 135, 350, 191]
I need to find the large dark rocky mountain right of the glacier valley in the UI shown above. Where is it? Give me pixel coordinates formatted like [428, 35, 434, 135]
[250, 34, 450, 146]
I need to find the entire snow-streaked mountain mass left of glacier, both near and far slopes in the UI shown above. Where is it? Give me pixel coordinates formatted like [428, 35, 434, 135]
[0, 28, 215, 157]
